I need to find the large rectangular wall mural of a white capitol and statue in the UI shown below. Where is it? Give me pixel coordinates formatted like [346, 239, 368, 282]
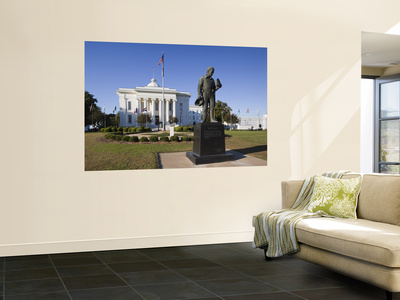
[84, 41, 267, 171]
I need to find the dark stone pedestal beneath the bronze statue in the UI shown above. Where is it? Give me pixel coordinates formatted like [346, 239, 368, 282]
[186, 123, 233, 165]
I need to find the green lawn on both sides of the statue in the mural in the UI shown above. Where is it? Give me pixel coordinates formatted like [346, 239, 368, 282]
[85, 131, 267, 171]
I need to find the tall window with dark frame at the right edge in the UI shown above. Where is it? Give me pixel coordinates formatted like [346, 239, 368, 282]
[375, 75, 400, 174]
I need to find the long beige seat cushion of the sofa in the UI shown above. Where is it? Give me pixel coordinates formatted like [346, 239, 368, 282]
[296, 217, 400, 268]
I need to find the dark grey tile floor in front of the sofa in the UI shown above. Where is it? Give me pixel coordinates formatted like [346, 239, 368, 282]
[0, 243, 400, 300]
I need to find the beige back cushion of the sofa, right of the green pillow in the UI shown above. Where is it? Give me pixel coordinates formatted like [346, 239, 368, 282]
[357, 174, 400, 225]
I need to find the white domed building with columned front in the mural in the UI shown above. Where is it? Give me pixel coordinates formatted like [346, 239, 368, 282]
[117, 78, 191, 128]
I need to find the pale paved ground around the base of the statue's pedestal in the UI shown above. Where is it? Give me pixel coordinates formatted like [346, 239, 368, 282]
[158, 150, 267, 169]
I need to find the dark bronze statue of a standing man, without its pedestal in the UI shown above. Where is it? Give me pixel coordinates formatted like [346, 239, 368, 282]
[195, 67, 222, 122]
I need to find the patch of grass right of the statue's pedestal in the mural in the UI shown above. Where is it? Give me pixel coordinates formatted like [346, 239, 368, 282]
[225, 130, 267, 160]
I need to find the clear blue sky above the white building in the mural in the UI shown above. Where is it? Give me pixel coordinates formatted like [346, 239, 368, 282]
[85, 42, 267, 117]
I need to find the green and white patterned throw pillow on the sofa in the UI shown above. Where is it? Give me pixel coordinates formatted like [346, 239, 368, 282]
[307, 176, 361, 219]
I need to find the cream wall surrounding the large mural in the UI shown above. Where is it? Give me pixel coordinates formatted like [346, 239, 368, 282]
[0, 0, 400, 256]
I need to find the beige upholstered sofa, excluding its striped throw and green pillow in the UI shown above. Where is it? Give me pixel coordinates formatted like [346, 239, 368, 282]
[256, 174, 400, 299]
